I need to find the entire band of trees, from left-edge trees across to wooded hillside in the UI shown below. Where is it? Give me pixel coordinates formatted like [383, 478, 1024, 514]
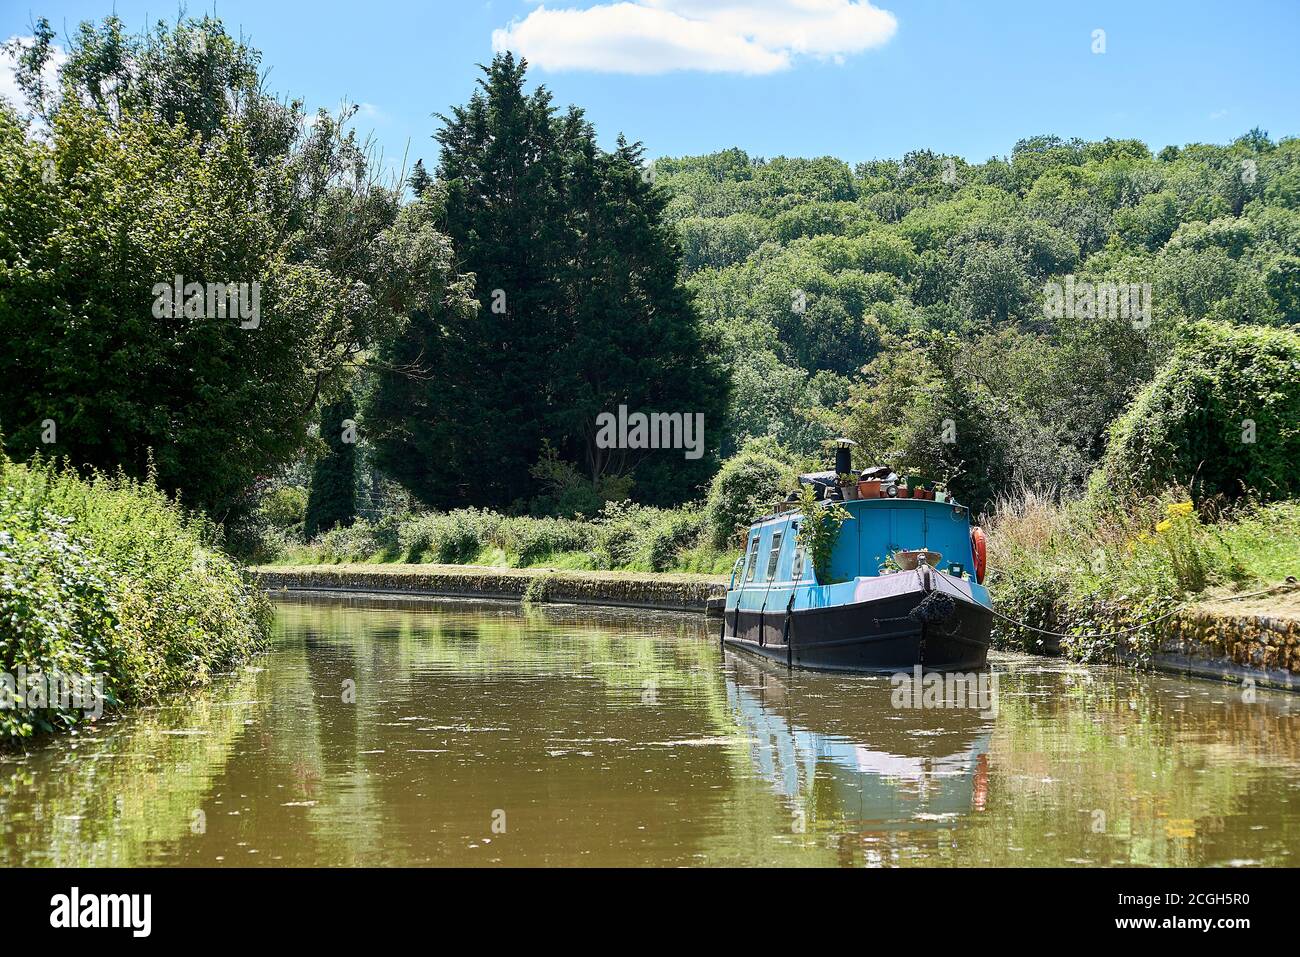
[0, 9, 1300, 540]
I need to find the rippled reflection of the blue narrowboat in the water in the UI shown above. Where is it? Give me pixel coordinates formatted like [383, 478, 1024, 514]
[727, 654, 992, 831]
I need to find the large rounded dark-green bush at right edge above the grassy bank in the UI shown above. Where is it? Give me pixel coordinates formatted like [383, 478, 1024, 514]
[1093, 322, 1300, 501]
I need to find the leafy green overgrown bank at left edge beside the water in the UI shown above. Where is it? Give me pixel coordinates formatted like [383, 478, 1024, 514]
[0, 455, 270, 744]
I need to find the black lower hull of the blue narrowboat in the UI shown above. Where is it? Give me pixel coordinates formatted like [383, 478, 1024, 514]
[723, 574, 993, 674]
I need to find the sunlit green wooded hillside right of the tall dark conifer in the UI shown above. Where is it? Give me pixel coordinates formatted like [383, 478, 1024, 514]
[657, 131, 1300, 512]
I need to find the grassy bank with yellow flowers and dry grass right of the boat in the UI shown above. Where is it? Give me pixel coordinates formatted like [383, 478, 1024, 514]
[988, 492, 1300, 661]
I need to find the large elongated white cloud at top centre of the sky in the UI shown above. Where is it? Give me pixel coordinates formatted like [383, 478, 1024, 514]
[491, 0, 898, 74]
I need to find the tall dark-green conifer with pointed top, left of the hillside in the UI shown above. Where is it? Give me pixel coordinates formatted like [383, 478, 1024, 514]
[369, 53, 727, 507]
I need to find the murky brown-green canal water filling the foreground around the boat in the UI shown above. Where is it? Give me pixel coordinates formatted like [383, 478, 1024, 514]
[0, 599, 1300, 866]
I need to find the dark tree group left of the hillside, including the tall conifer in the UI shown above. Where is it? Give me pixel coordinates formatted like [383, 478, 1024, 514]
[0, 17, 727, 531]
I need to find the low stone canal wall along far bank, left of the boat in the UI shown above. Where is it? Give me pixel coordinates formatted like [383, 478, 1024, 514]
[251, 564, 728, 615]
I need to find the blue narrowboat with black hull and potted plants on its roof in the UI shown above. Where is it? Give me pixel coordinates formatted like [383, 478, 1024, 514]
[723, 441, 993, 672]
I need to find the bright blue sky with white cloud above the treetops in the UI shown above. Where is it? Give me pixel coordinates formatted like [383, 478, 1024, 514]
[0, 0, 1300, 175]
